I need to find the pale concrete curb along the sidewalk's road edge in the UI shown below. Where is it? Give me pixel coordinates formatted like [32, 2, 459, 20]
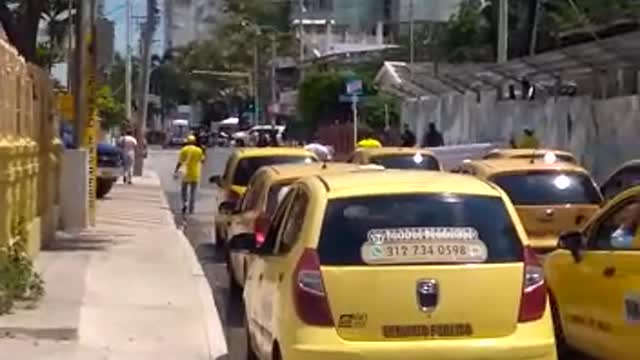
[145, 166, 229, 360]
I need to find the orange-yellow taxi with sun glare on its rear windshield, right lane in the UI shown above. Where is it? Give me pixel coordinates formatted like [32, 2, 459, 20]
[455, 158, 602, 251]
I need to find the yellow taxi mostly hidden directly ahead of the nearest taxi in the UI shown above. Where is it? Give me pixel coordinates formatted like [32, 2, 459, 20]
[221, 162, 368, 292]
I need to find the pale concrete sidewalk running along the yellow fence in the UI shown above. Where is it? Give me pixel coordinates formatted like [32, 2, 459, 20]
[0, 169, 227, 360]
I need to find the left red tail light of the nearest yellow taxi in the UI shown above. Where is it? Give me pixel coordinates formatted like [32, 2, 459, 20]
[293, 249, 334, 326]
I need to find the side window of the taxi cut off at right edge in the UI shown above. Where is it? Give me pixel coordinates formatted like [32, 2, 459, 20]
[589, 198, 640, 250]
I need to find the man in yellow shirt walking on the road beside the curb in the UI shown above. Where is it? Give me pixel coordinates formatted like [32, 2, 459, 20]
[174, 135, 205, 214]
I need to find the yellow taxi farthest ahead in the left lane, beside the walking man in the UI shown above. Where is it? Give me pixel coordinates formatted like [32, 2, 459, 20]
[209, 147, 318, 247]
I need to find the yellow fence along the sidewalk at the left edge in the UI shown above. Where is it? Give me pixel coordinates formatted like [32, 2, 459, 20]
[0, 40, 62, 256]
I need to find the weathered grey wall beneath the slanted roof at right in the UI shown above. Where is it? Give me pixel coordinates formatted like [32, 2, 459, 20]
[401, 94, 640, 180]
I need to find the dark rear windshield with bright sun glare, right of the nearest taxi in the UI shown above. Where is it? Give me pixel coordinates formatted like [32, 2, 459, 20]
[491, 171, 601, 206]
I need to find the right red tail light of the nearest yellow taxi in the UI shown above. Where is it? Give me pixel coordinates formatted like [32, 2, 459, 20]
[518, 246, 547, 322]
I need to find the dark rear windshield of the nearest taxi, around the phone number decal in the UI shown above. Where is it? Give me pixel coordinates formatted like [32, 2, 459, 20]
[317, 194, 522, 266]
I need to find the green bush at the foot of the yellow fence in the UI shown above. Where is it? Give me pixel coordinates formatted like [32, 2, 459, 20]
[0, 218, 44, 314]
